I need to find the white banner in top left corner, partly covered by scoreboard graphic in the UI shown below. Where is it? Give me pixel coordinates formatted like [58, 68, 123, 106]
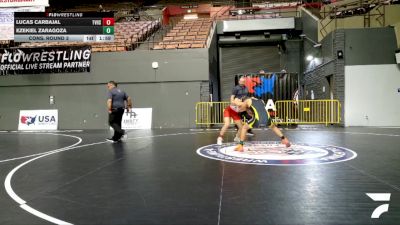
[0, 6, 45, 41]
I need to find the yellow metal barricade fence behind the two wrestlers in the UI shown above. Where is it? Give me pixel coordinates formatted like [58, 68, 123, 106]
[196, 100, 341, 126]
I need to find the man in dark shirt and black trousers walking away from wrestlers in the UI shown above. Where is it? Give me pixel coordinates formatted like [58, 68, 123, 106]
[107, 81, 132, 142]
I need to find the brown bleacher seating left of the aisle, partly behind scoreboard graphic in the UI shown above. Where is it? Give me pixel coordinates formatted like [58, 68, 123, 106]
[21, 21, 160, 52]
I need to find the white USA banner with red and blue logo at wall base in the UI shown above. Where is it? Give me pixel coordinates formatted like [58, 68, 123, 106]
[18, 109, 58, 130]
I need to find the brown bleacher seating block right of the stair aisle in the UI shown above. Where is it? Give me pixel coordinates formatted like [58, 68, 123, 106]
[153, 18, 213, 50]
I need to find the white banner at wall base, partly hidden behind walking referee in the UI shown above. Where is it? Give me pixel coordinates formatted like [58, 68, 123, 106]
[122, 108, 153, 130]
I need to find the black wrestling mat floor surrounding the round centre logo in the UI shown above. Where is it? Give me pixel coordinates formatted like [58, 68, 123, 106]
[0, 127, 400, 225]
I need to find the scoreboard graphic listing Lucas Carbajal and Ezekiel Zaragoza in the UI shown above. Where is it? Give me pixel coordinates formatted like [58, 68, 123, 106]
[14, 12, 115, 42]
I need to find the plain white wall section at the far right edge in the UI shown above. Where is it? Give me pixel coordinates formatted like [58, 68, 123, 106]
[344, 64, 400, 126]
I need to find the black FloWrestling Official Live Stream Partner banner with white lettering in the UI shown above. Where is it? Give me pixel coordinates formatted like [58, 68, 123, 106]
[0, 46, 91, 75]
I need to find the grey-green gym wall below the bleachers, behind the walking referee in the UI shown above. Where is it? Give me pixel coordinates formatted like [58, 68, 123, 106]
[0, 49, 209, 130]
